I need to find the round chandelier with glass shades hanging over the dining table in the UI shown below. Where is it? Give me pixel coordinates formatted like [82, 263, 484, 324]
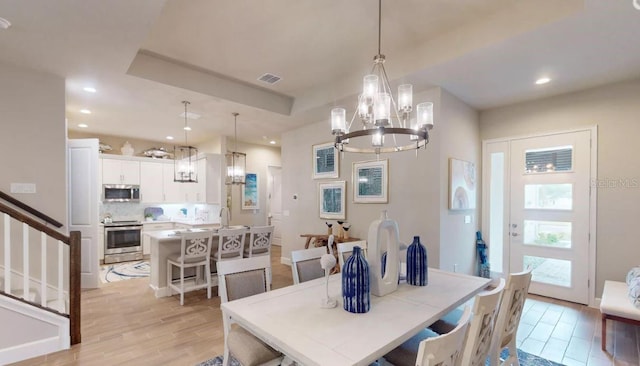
[331, 0, 433, 155]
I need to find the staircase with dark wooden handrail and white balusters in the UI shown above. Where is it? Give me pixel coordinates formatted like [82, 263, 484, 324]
[0, 192, 81, 365]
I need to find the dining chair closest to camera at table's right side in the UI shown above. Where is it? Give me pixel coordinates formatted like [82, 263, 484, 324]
[384, 306, 471, 366]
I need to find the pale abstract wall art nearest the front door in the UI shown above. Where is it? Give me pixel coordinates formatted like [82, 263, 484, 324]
[449, 158, 476, 210]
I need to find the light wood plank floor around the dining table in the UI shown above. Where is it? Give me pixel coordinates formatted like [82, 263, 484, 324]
[15, 247, 640, 366]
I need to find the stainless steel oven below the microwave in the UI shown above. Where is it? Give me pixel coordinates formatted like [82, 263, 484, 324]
[104, 221, 142, 264]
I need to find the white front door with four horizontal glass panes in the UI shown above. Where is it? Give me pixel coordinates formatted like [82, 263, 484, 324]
[508, 131, 591, 304]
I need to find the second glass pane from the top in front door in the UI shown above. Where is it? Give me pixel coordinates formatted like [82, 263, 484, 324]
[524, 183, 573, 210]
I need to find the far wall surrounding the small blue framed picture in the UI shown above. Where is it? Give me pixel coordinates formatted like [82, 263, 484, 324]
[228, 142, 282, 226]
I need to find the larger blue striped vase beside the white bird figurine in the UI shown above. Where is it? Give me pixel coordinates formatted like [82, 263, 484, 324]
[342, 246, 371, 313]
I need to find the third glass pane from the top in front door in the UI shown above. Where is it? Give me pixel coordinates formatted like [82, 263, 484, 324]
[523, 220, 571, 248]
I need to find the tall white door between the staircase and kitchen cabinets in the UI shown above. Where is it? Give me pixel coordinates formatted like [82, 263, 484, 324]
[67, 139, 100, 288]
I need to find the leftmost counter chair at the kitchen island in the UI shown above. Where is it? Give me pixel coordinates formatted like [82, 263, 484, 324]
[167, 230, 213, 305]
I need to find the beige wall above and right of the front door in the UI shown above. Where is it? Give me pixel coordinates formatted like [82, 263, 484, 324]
[480, 80, 640, 297]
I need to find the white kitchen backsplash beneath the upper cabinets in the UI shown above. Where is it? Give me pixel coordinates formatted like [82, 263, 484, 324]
[98, 202, 220, 221]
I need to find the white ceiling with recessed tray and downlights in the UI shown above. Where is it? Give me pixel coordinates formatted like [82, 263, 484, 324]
[0, 0, 640, 144]
